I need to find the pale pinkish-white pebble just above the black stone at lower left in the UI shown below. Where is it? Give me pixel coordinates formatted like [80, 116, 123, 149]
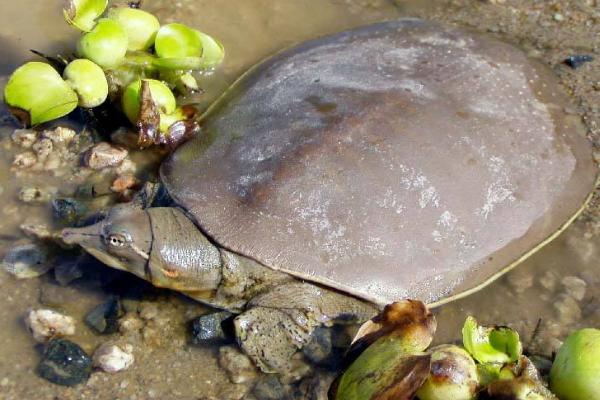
[25, 309, 75, 343]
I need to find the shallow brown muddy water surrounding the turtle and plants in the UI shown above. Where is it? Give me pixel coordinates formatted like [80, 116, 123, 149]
[0, 0, 600, 400]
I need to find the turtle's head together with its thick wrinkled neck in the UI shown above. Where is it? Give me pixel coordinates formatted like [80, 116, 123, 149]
[62, 205, 221, 293]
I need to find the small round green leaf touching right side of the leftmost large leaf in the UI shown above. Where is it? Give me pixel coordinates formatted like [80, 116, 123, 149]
[63, 59, 108, 108]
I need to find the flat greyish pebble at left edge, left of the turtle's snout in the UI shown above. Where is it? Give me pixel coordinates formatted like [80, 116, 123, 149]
[2, 243, 52, 279]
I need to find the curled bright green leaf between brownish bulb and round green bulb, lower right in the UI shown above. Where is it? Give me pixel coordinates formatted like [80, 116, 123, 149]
[462, 317, 523, 364]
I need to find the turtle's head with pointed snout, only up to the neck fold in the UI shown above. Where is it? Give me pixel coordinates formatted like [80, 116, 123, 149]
[62, 206, 152, 279]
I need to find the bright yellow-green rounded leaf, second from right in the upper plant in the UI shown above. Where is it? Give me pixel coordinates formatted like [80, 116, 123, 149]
[154, 23, 202, 58]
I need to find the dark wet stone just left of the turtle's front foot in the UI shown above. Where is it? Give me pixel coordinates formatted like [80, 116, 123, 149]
[191, 311, 235, 345]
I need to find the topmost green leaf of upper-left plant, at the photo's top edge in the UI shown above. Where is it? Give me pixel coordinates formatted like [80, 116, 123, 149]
[108, 7, 160, 51]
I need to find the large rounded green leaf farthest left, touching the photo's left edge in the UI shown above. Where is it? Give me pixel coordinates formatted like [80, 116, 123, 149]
[4, 62, 78, 125]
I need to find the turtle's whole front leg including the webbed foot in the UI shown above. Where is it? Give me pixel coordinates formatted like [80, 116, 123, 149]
[235, 282, 377, 374]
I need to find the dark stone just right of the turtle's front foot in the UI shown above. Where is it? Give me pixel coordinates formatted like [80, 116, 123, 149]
[302, 326, 350, 371]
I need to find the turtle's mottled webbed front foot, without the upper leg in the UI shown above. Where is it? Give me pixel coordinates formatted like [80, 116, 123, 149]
[235, 307, 314, 375]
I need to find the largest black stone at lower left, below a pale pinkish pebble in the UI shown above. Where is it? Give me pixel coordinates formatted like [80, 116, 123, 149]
[36, 339, 92, 386]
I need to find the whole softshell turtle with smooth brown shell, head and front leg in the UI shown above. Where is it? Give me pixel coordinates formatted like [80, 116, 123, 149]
[63, 20, 596, 371]
